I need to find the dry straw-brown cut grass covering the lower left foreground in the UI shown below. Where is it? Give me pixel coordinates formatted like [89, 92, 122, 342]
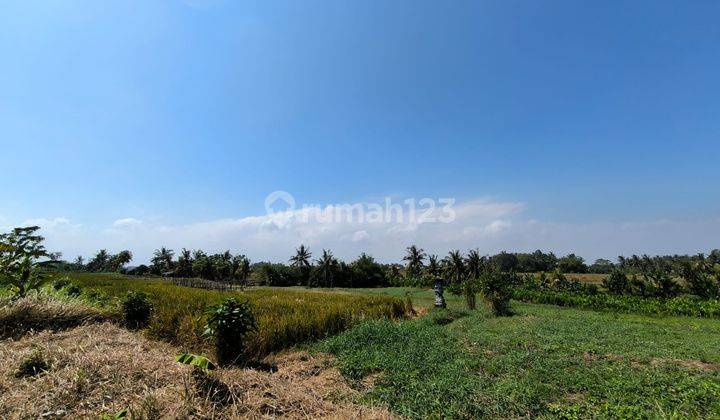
[0, 323, 393, 419]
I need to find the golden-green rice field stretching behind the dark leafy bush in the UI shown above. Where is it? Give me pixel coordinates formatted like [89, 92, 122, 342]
[54, 273, 404, 357]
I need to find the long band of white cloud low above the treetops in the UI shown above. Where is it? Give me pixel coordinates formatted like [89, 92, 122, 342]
[9, 199, 720, 263]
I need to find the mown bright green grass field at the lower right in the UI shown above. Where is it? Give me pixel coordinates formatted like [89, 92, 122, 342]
[315, 302, 720, 418]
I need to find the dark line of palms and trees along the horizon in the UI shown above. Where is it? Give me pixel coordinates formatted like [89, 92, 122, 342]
[54, 245, 720, 287]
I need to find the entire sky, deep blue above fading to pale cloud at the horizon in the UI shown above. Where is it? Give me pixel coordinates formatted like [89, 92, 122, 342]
[0, 0, 720, 260]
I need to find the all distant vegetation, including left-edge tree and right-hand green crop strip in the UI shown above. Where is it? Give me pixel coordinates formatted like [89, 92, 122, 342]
[5, 227, 720, 316]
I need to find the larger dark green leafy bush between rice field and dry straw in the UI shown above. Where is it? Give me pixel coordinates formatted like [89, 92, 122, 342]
[205, 298, 257, 365]
